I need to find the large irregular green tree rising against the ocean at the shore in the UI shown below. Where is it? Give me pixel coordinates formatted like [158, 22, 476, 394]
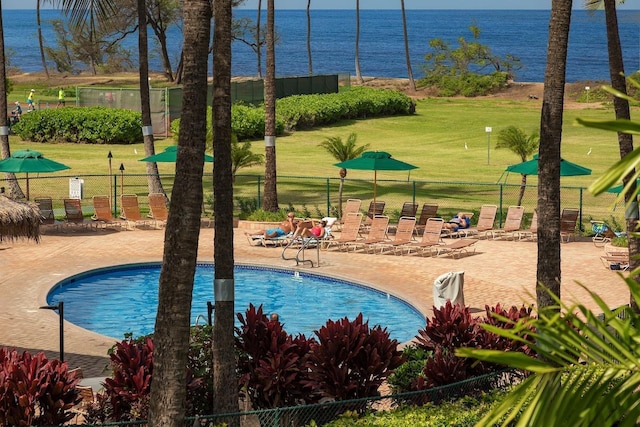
[418, 25, 521, 97]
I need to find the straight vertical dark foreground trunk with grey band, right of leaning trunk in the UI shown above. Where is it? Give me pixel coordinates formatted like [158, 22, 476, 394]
[213, 0, 239, 426]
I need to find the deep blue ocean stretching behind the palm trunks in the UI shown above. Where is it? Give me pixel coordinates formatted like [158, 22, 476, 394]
[2, 9, 640, 82]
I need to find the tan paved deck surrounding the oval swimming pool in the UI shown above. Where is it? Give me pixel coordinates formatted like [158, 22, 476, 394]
[0, 228, 629, 377]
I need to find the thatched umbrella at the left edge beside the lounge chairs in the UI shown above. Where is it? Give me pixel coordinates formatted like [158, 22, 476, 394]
[0, 195, 40, 242]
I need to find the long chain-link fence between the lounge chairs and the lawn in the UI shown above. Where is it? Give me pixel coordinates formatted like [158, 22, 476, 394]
[0, 171, 624, 233]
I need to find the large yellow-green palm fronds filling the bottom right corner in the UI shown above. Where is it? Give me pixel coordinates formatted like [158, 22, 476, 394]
[456, 278, 640, 427]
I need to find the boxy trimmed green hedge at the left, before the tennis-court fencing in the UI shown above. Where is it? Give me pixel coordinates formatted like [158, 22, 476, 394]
[12, 107, 142, 144]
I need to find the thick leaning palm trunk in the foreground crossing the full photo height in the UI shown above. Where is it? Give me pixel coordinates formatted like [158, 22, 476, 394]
[149, 0, 210, 427]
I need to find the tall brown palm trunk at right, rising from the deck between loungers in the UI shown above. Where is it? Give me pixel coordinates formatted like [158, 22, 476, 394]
[536, 0, 572, 307]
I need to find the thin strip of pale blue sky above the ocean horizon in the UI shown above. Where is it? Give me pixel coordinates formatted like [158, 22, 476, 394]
[7, 0, 640, 9]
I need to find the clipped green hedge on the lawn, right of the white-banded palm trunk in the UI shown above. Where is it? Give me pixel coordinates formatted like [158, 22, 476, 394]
[276, 86, 415, 130]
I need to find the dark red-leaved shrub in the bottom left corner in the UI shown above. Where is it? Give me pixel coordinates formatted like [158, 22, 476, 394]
[0, 348, 80, 426]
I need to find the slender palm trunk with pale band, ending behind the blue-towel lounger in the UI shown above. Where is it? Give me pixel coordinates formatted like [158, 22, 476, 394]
[262, 0, 278, 212]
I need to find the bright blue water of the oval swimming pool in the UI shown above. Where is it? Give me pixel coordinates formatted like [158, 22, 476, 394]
[47, 263, 425, 342]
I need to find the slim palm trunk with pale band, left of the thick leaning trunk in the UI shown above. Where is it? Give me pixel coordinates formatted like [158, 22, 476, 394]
[137, 0, 165, 194]
